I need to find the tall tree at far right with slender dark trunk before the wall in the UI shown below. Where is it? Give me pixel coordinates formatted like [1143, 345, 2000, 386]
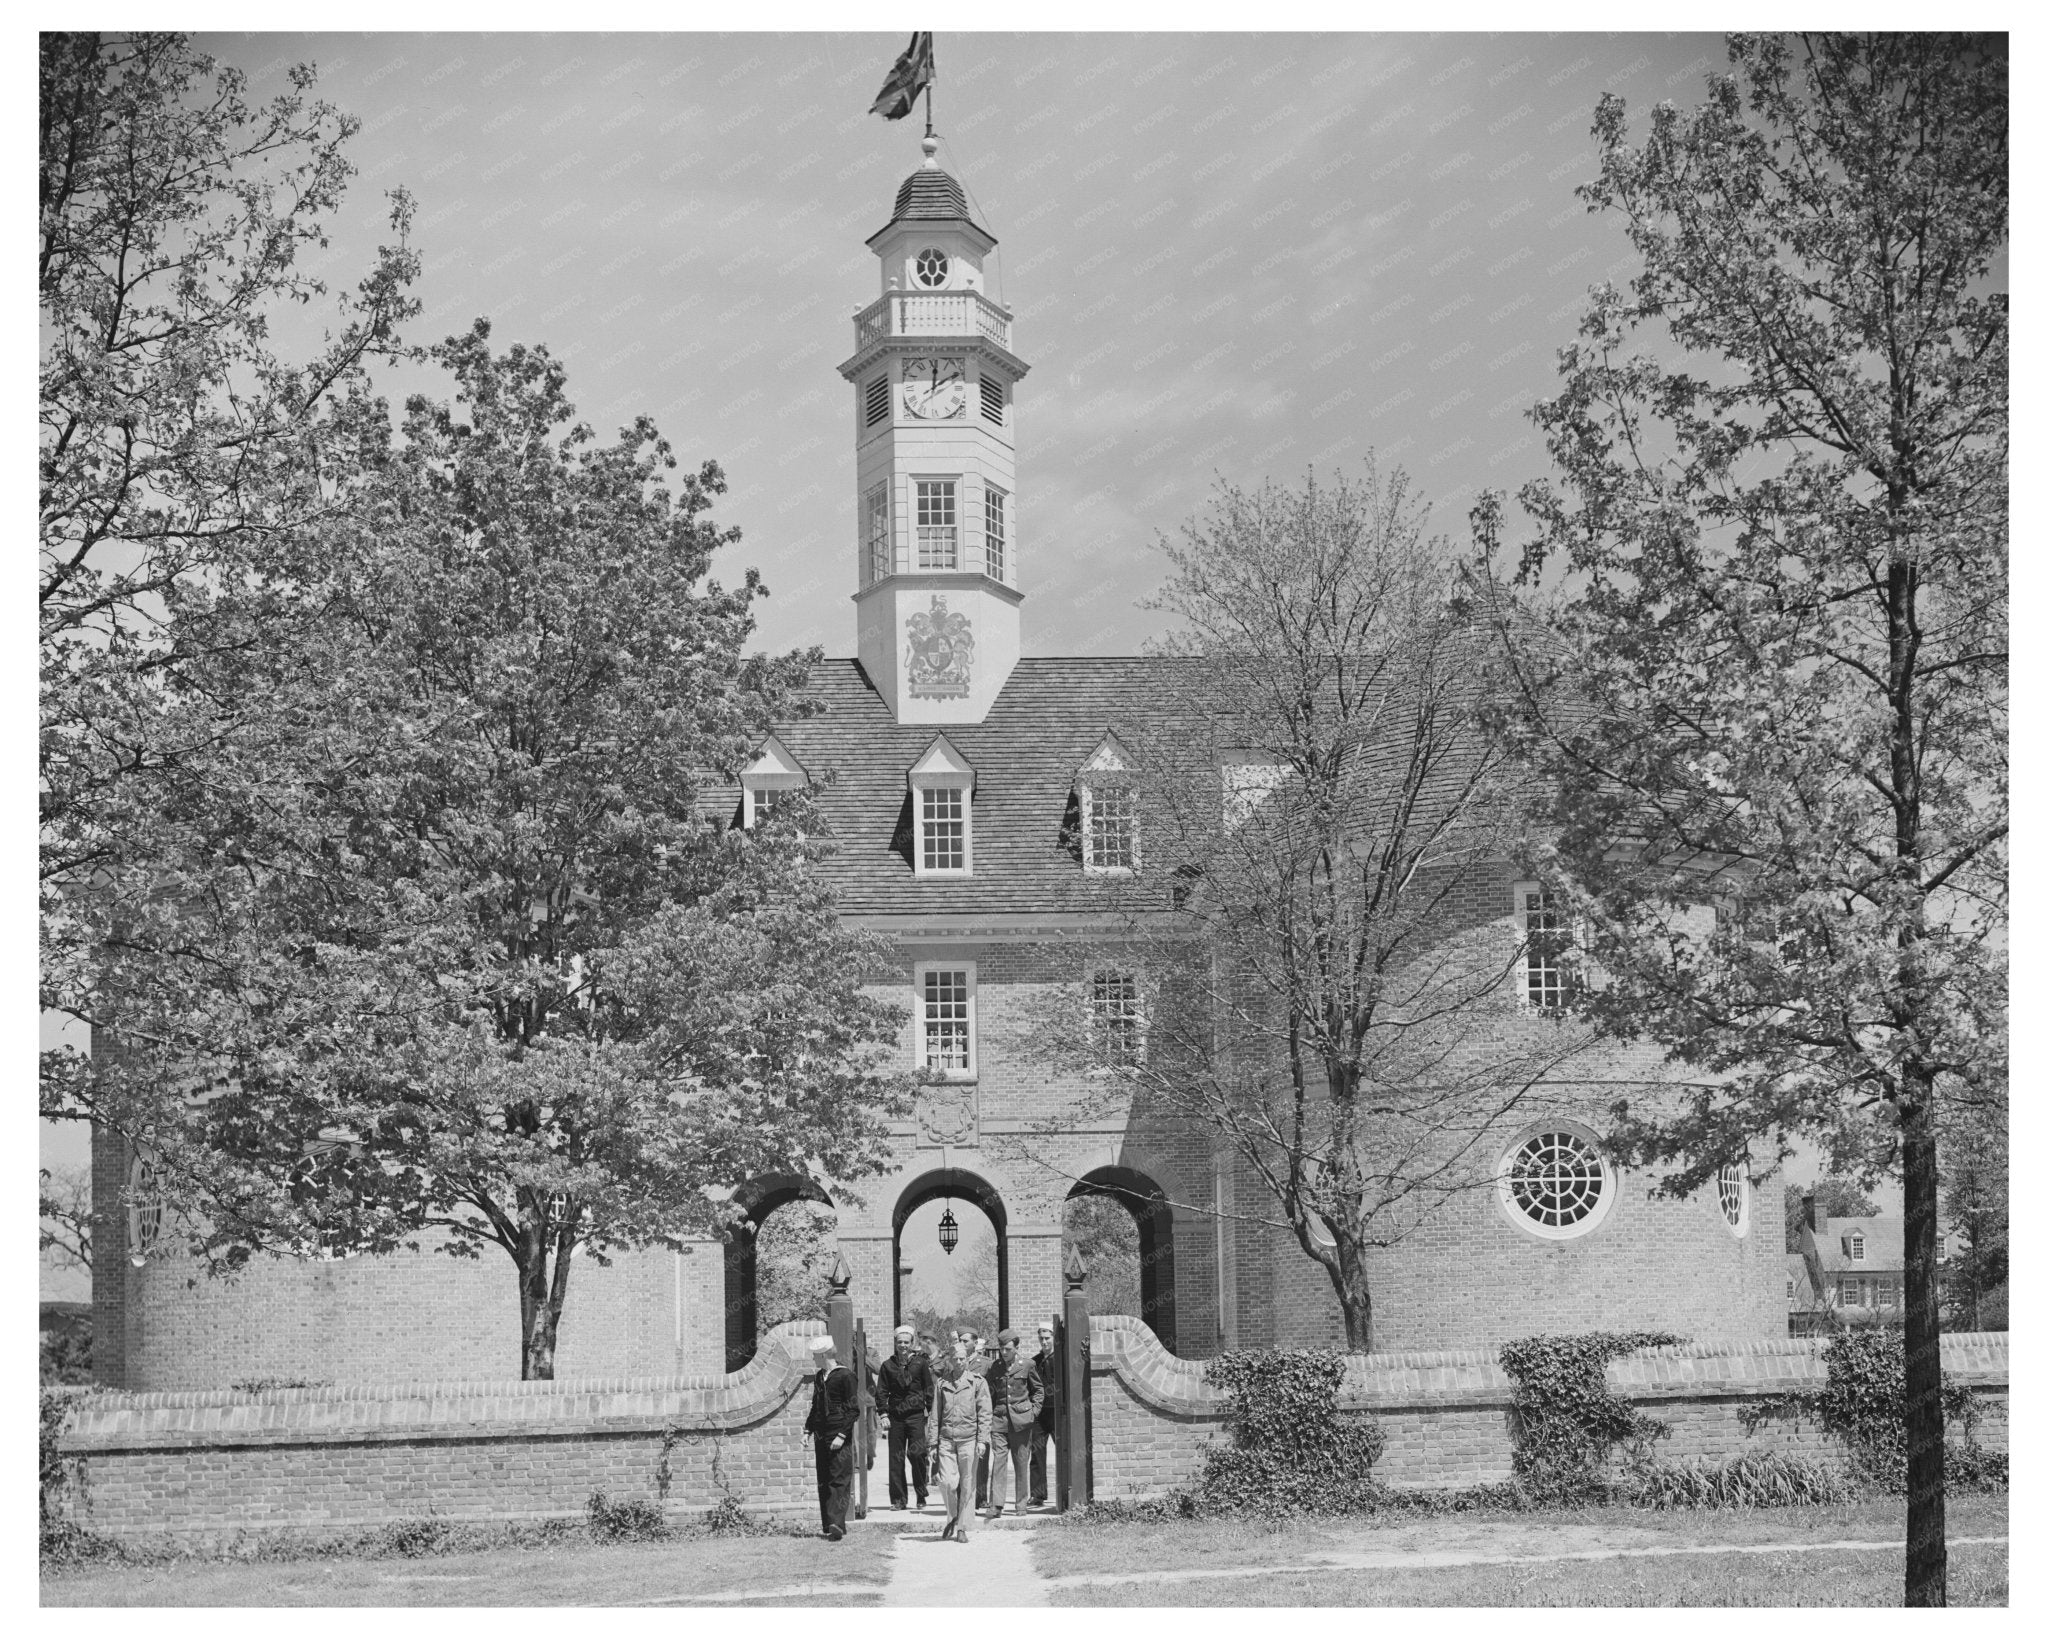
[1477, 35, 2009, 1604]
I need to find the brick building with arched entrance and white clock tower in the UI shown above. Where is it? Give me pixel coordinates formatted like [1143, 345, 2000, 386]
[94, 139, 1786, 1389]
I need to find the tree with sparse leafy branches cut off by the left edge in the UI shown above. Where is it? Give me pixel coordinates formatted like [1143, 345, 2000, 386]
[37, 33, 418, 1117]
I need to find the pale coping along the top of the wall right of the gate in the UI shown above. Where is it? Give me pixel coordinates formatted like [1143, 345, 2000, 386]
[1090, 1315, 2011, 1418]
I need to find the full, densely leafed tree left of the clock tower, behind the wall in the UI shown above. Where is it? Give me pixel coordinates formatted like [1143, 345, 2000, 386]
[92, 322, 903, 1377]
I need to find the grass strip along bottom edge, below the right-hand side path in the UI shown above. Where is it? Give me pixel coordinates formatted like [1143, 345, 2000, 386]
[1051, 1545, 2007, 1606]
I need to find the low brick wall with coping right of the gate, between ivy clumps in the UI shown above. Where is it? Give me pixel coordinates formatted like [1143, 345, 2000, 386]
[1090, 1315, 2009, 1500]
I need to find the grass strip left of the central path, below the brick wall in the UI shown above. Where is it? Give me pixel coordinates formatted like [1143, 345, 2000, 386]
[41, 1528, 895, 1606]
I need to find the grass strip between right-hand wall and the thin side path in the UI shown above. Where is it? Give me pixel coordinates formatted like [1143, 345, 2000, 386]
[1032, 1496, 2007, 1604]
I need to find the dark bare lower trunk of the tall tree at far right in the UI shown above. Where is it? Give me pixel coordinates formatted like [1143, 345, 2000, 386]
[1903, 1067, 1948, 1604]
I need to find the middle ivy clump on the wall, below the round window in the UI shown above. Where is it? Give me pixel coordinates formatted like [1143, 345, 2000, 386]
[1501, 1332, 1679, 1508]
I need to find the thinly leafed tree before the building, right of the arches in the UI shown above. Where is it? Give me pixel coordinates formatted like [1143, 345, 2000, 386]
[1030, 465, 1589, 1352]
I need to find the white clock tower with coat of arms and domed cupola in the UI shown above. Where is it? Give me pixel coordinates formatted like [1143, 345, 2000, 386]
[840, 137, 1026, 723]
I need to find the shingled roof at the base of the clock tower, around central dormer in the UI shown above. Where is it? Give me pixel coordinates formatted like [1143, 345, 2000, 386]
[707, 658, 1163, 916]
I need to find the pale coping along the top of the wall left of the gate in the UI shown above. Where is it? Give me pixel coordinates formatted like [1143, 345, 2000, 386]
[63, 1319, 825, 1446]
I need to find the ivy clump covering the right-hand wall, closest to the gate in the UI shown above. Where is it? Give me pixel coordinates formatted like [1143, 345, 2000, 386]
[1194, 1348, 1386, 1514]
